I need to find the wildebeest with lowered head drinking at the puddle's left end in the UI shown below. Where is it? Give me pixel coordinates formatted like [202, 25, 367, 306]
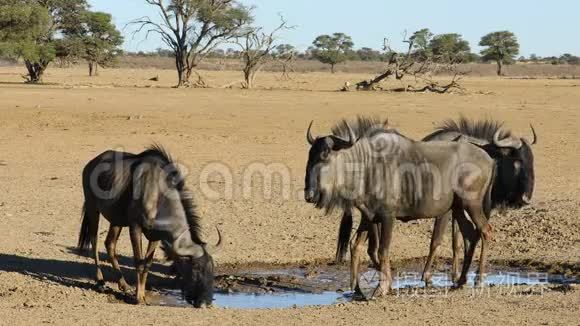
[78, 146, 221, 307]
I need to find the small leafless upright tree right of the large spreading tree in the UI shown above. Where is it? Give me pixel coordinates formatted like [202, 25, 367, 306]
[236, 17, 292, 89]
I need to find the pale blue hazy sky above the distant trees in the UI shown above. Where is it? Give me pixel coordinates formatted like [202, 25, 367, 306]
[89, 0, 580, 56]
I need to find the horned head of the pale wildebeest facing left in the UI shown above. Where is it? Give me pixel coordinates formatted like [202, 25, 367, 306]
[304, 121, 356, 207]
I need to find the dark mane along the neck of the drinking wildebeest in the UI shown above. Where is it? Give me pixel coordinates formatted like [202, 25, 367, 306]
[139, 144, 205, 245]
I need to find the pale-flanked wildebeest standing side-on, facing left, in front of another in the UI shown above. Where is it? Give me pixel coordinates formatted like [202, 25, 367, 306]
[305, 121, 495, 295]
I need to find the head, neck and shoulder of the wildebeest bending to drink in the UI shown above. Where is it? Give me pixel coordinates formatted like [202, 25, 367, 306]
[135, 148, 222, 307]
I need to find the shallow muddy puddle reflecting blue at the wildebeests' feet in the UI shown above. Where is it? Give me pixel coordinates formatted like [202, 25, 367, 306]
[153, 265, 579, 309]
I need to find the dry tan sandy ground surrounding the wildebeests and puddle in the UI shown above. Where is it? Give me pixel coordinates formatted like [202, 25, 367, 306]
[0, 68, 580, 325]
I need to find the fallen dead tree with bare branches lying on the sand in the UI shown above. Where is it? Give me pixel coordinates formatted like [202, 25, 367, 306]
[355, 35, 462, 93]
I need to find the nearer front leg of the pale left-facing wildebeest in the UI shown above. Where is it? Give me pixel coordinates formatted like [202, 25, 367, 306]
[373, 212, 395, 297]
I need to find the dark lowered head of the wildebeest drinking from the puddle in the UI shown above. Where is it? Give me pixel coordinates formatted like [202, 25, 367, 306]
[174, 230, 222, 308]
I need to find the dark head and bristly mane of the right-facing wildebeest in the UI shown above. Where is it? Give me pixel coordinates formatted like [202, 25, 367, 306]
[430, 118, 537, 208]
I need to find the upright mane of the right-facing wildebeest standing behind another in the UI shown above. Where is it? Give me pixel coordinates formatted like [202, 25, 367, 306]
[423, 116, 511, 143]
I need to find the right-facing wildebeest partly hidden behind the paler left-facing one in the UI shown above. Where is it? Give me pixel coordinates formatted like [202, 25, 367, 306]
[333, 117, 537, 285]
